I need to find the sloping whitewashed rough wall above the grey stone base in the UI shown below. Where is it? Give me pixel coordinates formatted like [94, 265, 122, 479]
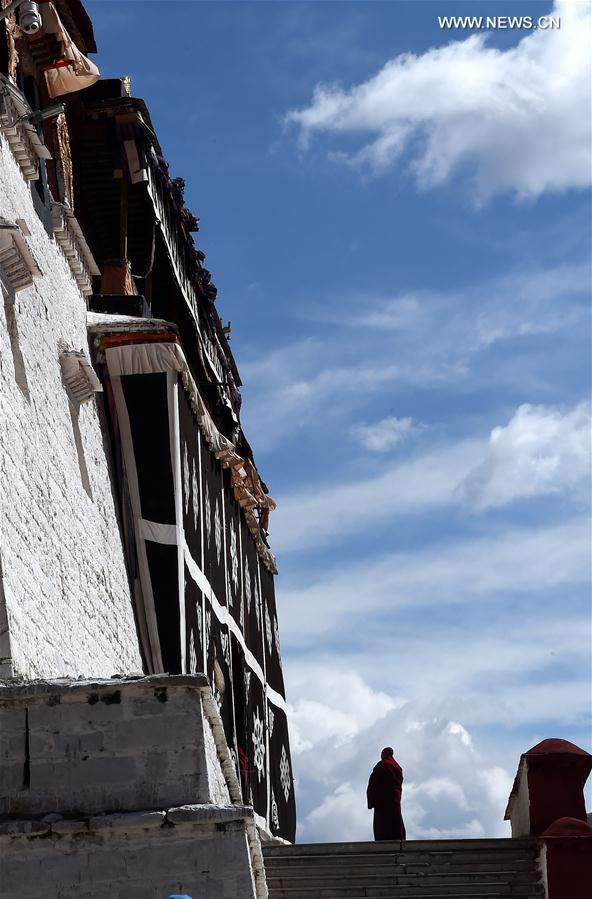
[0, 137, 142, 678]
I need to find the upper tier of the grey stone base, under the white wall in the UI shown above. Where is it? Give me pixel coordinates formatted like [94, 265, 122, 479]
[0, 675, 213, 817]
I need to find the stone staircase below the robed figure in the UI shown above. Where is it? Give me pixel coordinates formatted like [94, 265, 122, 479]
[263, 839, 546, 899]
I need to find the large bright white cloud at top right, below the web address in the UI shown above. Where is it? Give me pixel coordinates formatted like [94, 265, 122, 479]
[286, 0, 591, 197]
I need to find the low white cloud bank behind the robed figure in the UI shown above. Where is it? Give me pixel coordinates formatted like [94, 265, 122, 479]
[286, 628, 589, 841]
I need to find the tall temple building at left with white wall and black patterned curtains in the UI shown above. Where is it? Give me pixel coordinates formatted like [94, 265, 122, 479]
[0, 0, 295, 899]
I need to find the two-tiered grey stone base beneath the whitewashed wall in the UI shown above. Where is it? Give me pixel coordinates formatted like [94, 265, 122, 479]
[0, 675, 268, 899]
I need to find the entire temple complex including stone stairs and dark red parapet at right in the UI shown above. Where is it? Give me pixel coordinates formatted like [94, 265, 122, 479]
[0, 0, 592, 899]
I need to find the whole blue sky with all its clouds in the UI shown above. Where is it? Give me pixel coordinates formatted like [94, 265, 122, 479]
[87, 0, 591, 840]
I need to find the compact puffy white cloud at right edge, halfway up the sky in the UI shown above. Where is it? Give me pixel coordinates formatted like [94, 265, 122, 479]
[460, 402, 591, 509]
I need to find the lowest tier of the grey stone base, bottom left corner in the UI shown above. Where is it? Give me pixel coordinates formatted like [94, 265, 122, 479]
[0, 812, 256, 899]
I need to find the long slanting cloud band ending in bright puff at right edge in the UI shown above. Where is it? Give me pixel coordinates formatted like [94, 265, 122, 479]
[273, 403, 590, 553]
